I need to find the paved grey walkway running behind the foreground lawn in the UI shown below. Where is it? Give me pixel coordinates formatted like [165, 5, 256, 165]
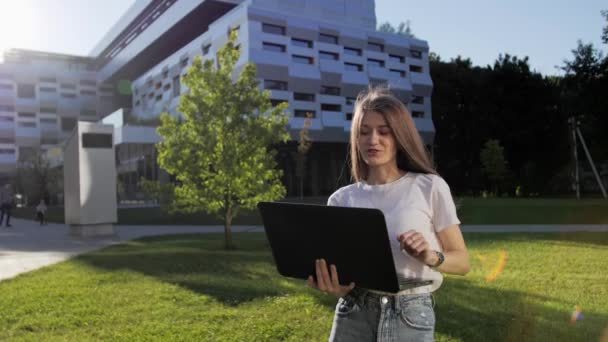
[0, 219, 608, 281]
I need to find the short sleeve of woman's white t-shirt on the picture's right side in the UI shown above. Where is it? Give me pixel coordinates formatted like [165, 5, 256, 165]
[431, 177, 460, 232]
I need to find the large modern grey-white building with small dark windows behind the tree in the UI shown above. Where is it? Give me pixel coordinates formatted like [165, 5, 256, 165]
[0, 0, 434, 195]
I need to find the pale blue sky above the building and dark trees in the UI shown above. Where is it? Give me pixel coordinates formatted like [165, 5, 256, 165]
[0, 0, 608, 75]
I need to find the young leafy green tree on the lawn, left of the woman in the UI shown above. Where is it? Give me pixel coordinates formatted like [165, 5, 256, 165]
[157, 31, 289, 248]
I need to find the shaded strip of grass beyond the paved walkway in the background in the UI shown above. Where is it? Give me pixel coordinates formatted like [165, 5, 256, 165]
[10, 197, 608, 225]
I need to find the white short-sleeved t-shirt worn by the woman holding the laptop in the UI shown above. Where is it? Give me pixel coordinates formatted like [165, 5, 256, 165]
[327, 172, 460, 294]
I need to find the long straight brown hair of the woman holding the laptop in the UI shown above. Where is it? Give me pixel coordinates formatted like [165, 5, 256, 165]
[350, 87, 437, 182]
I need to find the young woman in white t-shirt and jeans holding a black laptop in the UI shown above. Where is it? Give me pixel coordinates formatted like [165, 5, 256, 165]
[308, 88, 470, 341]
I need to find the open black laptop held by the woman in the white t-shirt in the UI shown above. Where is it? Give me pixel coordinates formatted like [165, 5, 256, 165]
[258, 202, 399, 293]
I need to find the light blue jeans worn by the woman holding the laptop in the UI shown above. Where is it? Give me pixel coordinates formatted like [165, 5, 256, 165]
[329, 288, 435, 342]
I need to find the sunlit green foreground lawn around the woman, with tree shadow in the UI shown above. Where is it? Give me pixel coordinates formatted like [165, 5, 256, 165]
[0, 233, 608, 342]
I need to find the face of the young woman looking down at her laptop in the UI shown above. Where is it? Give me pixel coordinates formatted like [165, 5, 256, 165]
[357, 112, 397, 167]
